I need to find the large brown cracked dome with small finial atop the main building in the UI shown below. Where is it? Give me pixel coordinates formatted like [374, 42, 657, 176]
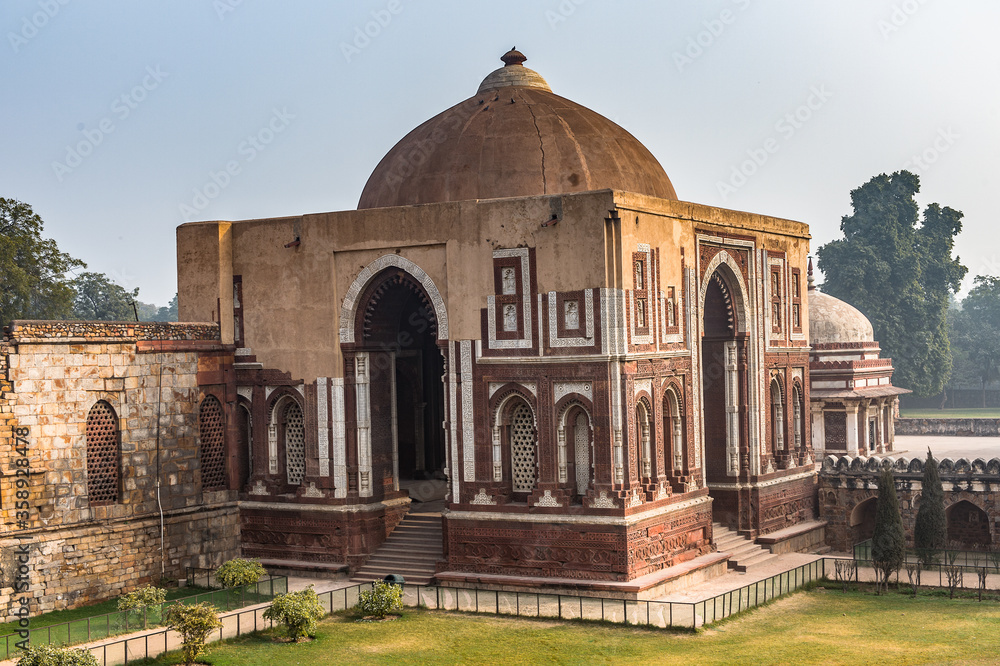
[358, 49, 677, 208]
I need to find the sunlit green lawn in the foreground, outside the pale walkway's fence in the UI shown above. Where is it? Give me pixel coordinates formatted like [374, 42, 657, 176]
[139, 589, 1000, 666]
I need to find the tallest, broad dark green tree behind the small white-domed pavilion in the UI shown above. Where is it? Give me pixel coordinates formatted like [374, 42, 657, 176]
[817, 171, 966, 396]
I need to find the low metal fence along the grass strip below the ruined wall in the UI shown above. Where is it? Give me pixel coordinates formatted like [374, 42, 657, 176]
[0, 576, 288, 659]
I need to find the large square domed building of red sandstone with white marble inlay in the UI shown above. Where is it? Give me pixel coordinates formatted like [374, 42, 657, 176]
[177, 51, 816, 586]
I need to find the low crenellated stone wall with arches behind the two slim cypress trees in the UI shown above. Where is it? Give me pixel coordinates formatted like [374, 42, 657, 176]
[819, 456, 1000, 552]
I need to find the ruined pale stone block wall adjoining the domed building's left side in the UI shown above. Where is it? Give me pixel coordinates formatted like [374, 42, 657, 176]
[0, 322, 239, 613]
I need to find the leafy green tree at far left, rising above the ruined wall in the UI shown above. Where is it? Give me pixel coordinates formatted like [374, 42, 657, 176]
[0, 199, 86, 324]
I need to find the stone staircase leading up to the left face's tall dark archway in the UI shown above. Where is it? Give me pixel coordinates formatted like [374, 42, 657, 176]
[351, 502, 444, 585]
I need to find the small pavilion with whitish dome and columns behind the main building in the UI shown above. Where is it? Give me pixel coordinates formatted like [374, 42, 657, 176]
[809, 264, 910, 456]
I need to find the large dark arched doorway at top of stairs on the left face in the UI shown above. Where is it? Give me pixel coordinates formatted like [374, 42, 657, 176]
[356, 267, 442, 492]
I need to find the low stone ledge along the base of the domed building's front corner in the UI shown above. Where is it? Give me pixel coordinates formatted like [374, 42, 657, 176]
[434, 553, 730, 600]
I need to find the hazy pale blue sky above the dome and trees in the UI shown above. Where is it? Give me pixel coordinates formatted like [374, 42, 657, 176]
[0, 0, 1000, 305]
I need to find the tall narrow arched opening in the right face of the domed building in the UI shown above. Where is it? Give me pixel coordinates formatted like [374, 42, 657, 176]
[701, 265, 745, 529]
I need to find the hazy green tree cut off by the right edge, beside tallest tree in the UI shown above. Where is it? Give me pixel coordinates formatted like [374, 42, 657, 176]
[951, 275, 1000, 407]
